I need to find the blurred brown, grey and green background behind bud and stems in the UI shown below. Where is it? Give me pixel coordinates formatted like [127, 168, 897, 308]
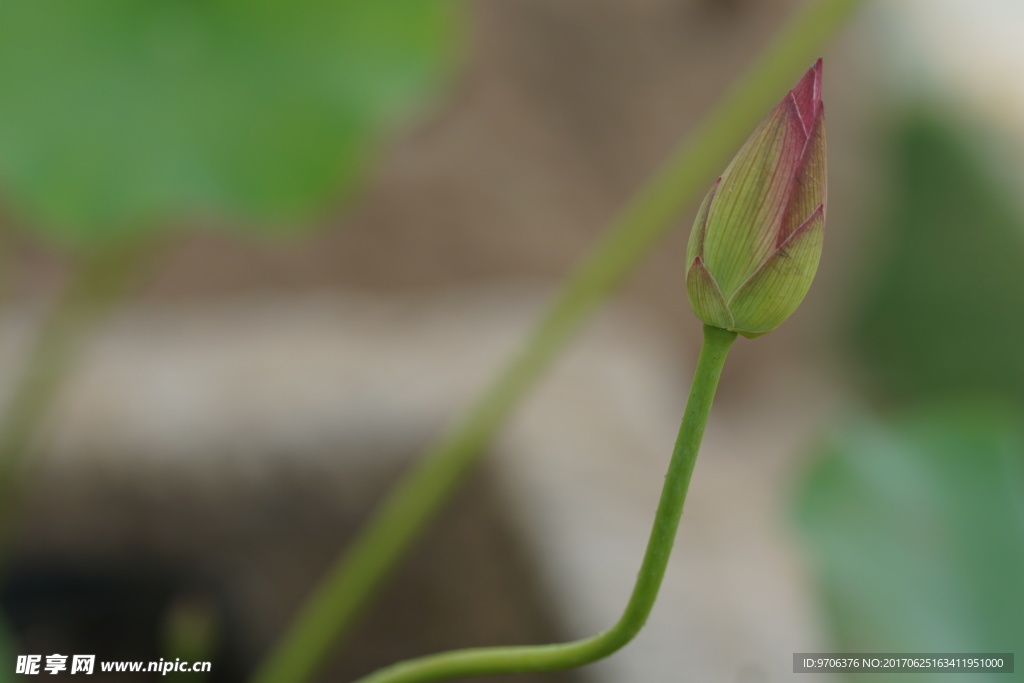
[0, 0, 1024, 683]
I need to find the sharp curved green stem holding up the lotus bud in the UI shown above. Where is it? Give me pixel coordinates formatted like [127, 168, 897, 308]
[356, 326, 736, 683]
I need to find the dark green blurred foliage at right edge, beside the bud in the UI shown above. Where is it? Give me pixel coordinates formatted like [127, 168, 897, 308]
[849, 111, 1024, 401]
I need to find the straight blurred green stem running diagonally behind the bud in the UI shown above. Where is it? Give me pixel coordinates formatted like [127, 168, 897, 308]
[252, 0, 863, 683]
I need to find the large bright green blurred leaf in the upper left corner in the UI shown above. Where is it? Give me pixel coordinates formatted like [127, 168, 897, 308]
[0, 0, 457, 243]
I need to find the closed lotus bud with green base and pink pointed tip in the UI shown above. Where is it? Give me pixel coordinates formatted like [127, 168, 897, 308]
[686, 59, 825, 338]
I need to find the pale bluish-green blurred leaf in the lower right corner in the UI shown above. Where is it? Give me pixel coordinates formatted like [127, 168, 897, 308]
[797, 403, 1024, 683]
